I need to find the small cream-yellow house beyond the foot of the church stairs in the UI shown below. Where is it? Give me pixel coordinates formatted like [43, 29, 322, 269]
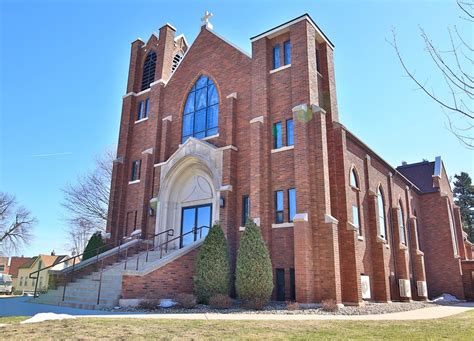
[15, 255, 68, 292]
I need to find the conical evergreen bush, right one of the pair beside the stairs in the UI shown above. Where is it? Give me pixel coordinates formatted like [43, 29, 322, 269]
[235, 219, 273, 309]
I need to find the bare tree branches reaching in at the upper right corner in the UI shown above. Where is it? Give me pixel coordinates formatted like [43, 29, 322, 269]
[390, 0, 474, 149]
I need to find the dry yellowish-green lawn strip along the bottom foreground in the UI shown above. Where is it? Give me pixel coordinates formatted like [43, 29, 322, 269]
[0, 310, 474, 340]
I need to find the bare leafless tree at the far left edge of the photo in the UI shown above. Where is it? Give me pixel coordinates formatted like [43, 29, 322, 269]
[0, 192, 37, 254]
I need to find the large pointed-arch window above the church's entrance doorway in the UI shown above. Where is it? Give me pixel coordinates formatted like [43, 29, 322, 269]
[182, 76, 219, 143]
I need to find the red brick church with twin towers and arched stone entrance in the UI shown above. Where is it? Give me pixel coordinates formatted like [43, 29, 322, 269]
[107, 14, 474, 304]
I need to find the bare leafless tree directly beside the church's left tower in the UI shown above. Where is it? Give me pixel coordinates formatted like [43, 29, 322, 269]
[62, 150, 114, 253]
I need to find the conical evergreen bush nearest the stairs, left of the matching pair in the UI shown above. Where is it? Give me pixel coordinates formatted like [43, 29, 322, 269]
[194, 224, 230, 304]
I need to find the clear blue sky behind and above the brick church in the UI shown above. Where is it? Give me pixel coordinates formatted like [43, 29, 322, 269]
[0, 0, 474, 256]
